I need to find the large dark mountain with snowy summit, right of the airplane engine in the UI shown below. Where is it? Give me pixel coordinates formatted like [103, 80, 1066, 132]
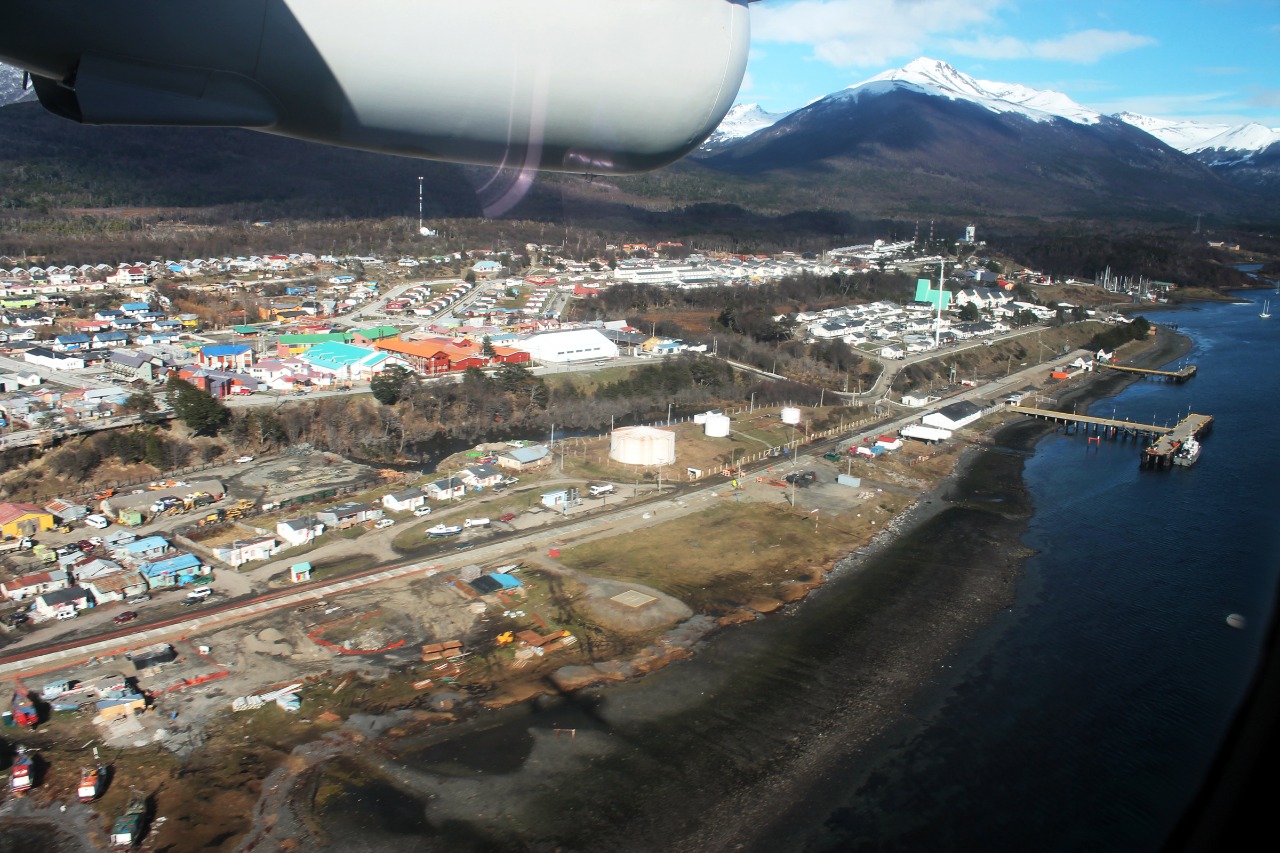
[696, 59, 1267, 216]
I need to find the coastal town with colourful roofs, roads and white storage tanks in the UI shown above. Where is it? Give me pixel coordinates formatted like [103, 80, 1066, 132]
[0, 229, 1177, 849]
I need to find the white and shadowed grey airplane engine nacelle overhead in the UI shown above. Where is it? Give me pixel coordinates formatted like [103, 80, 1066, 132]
[0, 0, 749, 174]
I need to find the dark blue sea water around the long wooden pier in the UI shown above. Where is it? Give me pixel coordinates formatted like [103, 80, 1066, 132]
[808, 292, 1280, 850]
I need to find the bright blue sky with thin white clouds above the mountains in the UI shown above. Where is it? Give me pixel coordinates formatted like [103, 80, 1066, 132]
[737, 0, 1280, 128]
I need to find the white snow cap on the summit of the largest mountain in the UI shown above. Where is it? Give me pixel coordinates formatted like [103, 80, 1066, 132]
[845, 56, 1102, 124]
